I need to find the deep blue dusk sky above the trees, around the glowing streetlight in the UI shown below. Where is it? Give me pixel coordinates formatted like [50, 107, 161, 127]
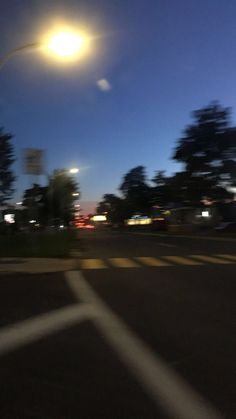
[0, 0, 236, 210]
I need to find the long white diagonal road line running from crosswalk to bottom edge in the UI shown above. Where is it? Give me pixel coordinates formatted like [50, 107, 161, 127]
[66, 271, 222, 419]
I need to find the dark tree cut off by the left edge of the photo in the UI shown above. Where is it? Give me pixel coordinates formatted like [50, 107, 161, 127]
[0, 128, 15, 206]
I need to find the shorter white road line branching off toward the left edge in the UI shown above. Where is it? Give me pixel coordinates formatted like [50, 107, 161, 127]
[0, 304, 93, 355]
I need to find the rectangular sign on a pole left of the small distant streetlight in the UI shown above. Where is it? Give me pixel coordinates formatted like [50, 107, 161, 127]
[24, 148, 45, 175]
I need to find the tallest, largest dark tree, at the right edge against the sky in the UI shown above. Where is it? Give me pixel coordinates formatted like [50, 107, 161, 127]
[173, 102, 236, 203]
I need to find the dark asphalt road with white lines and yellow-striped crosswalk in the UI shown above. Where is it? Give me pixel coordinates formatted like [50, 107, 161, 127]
[0, 231, 236, 419]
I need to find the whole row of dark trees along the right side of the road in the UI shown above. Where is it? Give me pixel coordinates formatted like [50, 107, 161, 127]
[97, 102, 236, 223]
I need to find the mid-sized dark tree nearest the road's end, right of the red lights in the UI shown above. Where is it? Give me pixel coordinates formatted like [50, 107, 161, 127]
[119, 166, 151, 216]
